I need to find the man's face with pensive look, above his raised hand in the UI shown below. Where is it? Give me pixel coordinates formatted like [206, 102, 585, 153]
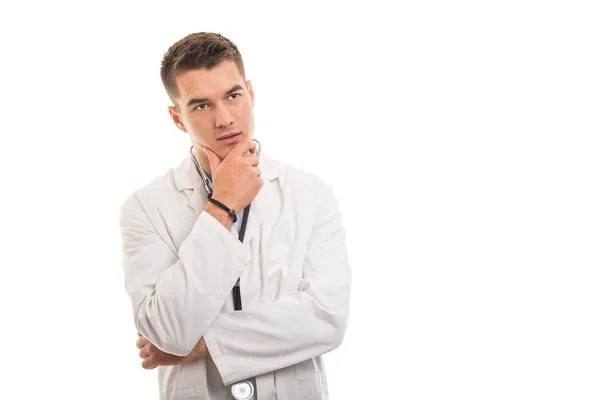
[169, 61, 254, 159]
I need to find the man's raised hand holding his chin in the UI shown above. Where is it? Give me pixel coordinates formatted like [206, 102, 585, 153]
[204, 140, 264, 212]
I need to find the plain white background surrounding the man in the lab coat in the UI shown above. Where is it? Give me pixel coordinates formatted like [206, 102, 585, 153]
[0, 1, 600, 400]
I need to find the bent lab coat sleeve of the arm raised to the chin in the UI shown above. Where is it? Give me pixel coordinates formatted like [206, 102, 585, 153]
[119, 194, 251, 356]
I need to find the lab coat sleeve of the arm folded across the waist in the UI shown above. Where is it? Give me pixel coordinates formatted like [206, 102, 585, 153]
[204, 181, 351, 385]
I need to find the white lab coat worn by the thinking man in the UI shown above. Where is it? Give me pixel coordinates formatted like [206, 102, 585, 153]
[117, 152, 351, 400]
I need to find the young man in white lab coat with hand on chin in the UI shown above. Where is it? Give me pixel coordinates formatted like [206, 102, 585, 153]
[120, 32, 351, 400]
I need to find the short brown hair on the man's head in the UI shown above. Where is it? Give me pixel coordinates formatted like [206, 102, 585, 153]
[160, 32, 246, 106]
